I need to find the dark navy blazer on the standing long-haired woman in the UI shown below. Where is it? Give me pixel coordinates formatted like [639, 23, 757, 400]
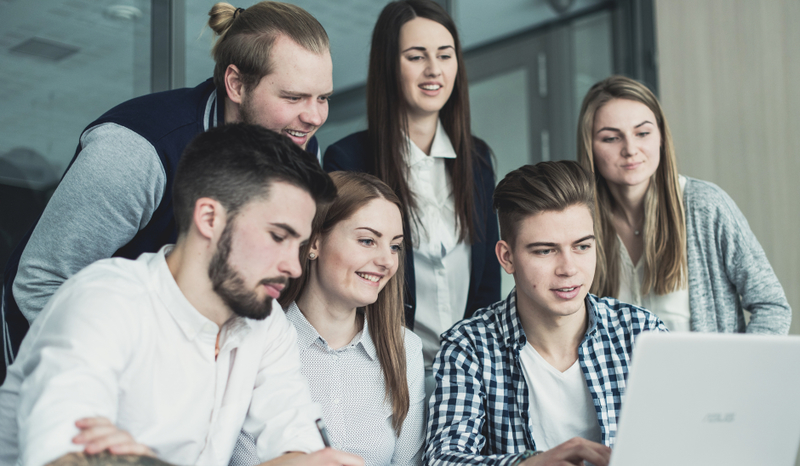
[322, 131, 500, 330]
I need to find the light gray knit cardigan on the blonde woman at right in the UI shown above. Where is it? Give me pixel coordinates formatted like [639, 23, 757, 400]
[683, 177, 792, 335]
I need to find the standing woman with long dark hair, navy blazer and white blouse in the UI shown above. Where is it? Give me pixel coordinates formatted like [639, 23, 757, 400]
[323, 0, 500, 391]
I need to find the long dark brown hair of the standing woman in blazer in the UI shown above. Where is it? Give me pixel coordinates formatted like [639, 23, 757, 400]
[367, 0, 477, 244]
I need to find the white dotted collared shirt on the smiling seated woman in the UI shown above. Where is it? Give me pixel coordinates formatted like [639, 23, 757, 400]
[286, 303, 425, 466]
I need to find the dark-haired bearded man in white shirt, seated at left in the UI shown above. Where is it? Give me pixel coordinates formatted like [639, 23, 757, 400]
[0, 124, 364, 466]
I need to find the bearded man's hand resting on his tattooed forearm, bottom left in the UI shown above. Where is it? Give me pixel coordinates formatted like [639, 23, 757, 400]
[72, 417, 156, 457]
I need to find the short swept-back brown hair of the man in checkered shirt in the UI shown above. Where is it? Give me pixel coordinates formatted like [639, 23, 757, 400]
[494, 160, 594, 248]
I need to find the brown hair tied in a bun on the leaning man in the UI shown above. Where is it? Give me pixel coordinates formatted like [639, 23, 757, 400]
[208, 2, 330, 90]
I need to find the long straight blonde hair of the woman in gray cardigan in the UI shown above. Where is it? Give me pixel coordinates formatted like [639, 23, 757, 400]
[578, 76, 688, 296]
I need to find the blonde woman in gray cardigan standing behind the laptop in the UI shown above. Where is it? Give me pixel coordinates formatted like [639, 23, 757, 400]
[578, 76, 792, 334]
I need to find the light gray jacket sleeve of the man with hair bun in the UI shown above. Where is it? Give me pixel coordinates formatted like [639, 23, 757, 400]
[13, 123, 166, 322]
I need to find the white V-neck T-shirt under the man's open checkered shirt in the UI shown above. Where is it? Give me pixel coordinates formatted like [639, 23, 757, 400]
[520, 343, 601, 450]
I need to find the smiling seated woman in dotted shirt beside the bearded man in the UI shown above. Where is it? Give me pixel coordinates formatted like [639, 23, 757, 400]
[280, 172, 425, 466]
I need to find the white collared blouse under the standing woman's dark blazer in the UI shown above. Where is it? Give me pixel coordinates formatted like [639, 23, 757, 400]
[406, 121, 472, 369]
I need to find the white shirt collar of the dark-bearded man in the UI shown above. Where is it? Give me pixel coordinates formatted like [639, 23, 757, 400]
[148, 244, 252, 341]
